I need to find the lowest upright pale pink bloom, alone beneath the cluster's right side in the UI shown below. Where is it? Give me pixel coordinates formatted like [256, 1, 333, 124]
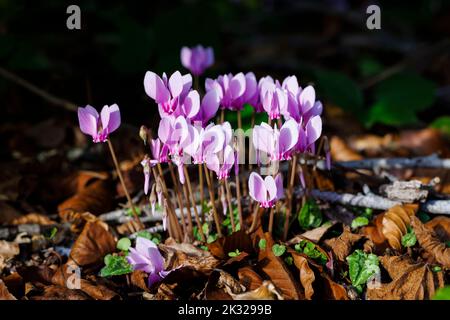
[248, 172, 284, 208]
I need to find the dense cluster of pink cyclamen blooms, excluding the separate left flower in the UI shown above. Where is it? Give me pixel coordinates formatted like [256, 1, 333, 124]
[142, 47, 323, 207]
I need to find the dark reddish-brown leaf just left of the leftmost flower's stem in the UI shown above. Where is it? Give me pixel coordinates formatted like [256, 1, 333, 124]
[58, 180, 114, 215]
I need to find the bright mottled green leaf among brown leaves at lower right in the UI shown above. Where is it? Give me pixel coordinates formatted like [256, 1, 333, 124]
[347, 249, 380, 291]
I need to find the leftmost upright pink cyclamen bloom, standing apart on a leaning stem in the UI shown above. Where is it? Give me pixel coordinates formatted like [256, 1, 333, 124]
[78, 104, 120, 143]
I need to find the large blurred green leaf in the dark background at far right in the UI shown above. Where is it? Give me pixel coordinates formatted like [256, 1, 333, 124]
[365, 73, 436, 126]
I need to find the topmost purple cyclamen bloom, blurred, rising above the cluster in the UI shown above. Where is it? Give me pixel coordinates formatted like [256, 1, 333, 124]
[180, 45, 214, 76]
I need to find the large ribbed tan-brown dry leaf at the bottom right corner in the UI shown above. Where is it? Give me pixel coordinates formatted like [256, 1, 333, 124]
[367, 256, 444, 300]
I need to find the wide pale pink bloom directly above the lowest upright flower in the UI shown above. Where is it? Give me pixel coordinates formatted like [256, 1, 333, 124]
[252, 119, 299, 161]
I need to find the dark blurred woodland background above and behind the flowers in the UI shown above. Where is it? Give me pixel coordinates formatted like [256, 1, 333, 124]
[0, 0, 450, 142]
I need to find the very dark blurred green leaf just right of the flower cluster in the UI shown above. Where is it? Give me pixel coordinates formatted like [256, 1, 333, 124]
[315, 70, 364, 115]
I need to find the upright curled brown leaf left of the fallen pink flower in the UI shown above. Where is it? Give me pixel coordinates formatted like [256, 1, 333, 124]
[70, 221, 116, 266]
